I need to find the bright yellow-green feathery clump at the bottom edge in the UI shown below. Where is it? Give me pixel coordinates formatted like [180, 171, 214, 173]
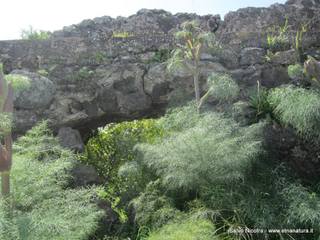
[147, 219, 219, 240]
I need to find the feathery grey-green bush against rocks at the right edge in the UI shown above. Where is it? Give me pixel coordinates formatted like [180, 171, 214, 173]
[268, 86, 320, 138]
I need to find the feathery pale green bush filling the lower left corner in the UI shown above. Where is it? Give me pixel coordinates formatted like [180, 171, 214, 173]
[0, 123, 102, 240]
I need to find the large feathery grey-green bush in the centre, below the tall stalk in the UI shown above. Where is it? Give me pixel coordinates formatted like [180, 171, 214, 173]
[138, 113, 261, 192]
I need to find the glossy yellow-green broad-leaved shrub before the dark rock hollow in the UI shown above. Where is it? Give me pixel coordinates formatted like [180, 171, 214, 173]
[82, 119, 163, 182]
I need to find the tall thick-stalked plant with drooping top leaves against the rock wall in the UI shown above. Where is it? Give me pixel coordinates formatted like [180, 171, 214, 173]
[167, 21, 221, 108]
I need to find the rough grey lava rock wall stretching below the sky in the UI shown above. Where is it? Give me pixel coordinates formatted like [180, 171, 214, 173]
[0, 0, 320, 138]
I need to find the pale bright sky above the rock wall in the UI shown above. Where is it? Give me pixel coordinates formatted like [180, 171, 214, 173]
[0, 0, 285, 40]
